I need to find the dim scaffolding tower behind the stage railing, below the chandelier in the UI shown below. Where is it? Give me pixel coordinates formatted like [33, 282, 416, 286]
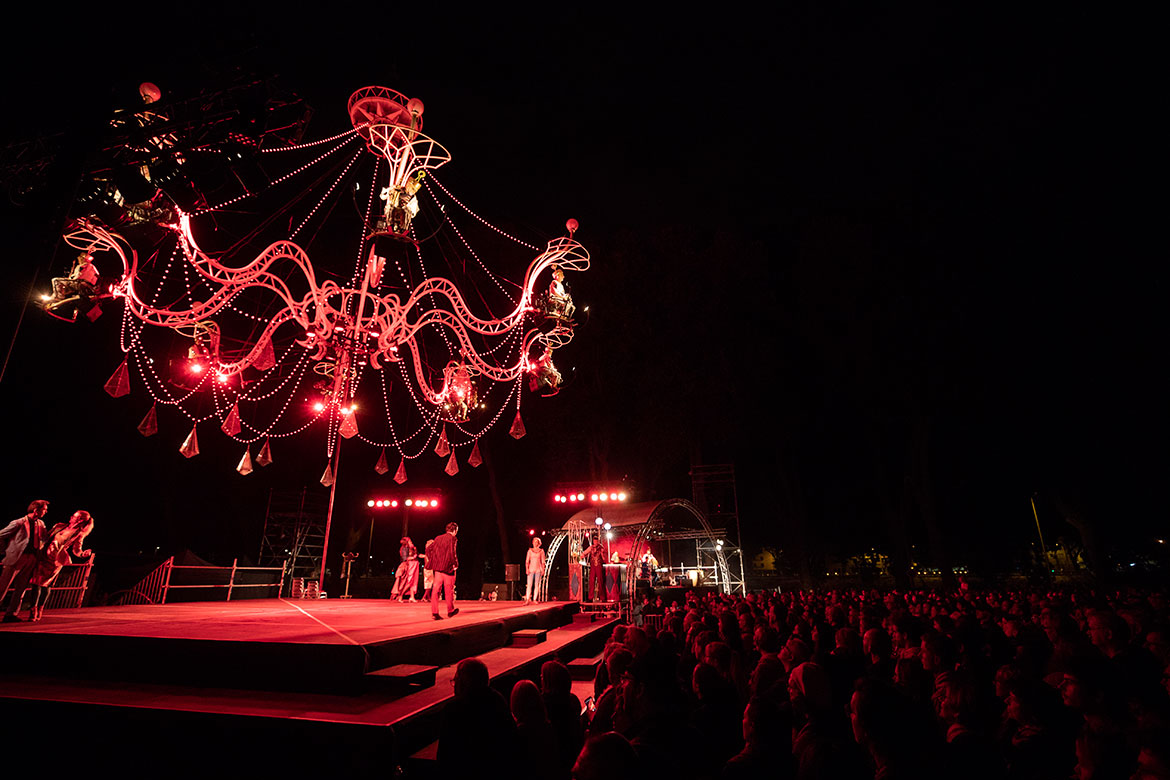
[260, 488, 329, 588]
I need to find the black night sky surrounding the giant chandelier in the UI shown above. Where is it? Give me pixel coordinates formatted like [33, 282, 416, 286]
[0, 4, 1168, 591]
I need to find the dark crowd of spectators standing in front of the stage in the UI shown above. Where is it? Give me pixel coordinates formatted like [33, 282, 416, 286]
[440, 586, 1170, 780]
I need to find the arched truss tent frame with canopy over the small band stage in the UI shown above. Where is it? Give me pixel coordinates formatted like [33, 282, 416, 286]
[542, 498, 731, 613]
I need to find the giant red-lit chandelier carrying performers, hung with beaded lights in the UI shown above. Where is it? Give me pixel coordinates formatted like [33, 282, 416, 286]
[50, 85, 590, 485]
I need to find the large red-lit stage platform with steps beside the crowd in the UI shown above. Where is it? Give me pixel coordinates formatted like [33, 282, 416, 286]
[0, 599, 614, 776]
